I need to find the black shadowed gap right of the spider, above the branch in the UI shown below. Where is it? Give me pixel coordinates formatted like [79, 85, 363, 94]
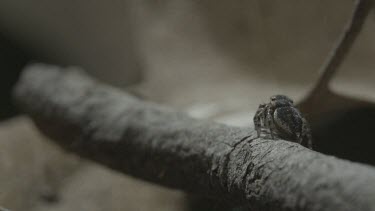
[313, 107, 375, 165]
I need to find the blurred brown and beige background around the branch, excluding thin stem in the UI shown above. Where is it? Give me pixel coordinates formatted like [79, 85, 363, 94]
[0, 0, 375, 211]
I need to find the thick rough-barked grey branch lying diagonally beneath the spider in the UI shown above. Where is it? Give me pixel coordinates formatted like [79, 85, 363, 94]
[14, 65, 375, 211]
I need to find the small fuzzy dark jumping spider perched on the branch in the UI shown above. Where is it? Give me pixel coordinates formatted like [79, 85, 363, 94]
[254, 95, 312, 149]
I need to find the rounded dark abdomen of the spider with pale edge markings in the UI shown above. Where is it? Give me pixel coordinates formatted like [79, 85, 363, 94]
[273, 107, 303, 139]
